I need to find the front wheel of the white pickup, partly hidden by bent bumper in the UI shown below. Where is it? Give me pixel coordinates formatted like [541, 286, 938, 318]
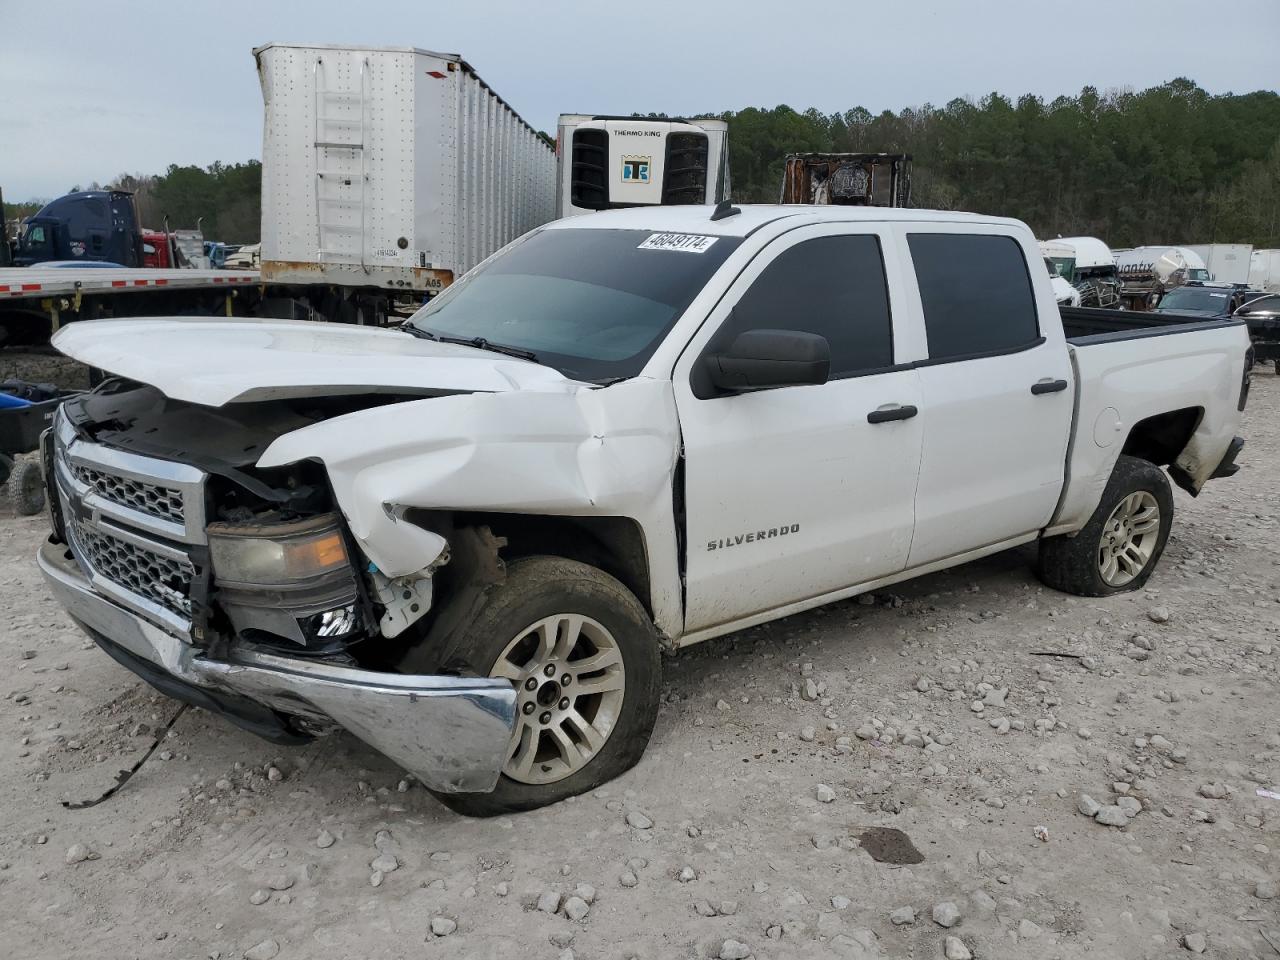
[435, 557, 662, 817]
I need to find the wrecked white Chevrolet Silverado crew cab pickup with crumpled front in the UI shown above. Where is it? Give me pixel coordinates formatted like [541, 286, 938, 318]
[40, 204, 1251, 814]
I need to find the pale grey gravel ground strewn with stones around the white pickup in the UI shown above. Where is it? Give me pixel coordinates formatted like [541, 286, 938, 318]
[0, 372, 1280, 960]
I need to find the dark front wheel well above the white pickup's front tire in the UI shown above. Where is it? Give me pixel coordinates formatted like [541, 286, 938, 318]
[407, 511, 653, 617]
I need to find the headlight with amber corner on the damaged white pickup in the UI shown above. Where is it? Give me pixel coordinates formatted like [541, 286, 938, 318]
[209, 513, 351, 586]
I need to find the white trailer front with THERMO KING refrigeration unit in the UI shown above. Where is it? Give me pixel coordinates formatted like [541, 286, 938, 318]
[556, 114, 730, 216]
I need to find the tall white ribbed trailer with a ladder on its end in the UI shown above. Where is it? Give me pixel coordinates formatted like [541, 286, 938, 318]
[253, 44, 556, 321]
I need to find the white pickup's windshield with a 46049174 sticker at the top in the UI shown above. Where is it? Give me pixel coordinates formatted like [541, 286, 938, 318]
[408, 228, 742, 380]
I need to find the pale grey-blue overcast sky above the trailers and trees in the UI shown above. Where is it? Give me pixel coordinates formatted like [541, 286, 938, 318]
[0, 0, 1280, 202]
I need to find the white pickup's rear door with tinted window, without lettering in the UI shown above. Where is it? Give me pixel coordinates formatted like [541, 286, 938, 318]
[897, 224, 1075, 567]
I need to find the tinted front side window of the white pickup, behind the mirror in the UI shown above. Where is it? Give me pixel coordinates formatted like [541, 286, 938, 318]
[708, 236, 893, 379]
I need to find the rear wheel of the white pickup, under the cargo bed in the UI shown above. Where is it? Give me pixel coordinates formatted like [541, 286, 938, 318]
[1037, 456, 1174, 596]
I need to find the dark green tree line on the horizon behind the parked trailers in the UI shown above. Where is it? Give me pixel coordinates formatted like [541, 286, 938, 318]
[5, 78, 1280, 247]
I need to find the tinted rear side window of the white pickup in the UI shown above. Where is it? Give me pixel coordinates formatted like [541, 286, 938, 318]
[908, 233, 1039, 360]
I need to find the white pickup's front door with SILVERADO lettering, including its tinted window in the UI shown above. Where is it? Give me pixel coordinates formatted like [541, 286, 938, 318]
[673, 224, 920, 632]
